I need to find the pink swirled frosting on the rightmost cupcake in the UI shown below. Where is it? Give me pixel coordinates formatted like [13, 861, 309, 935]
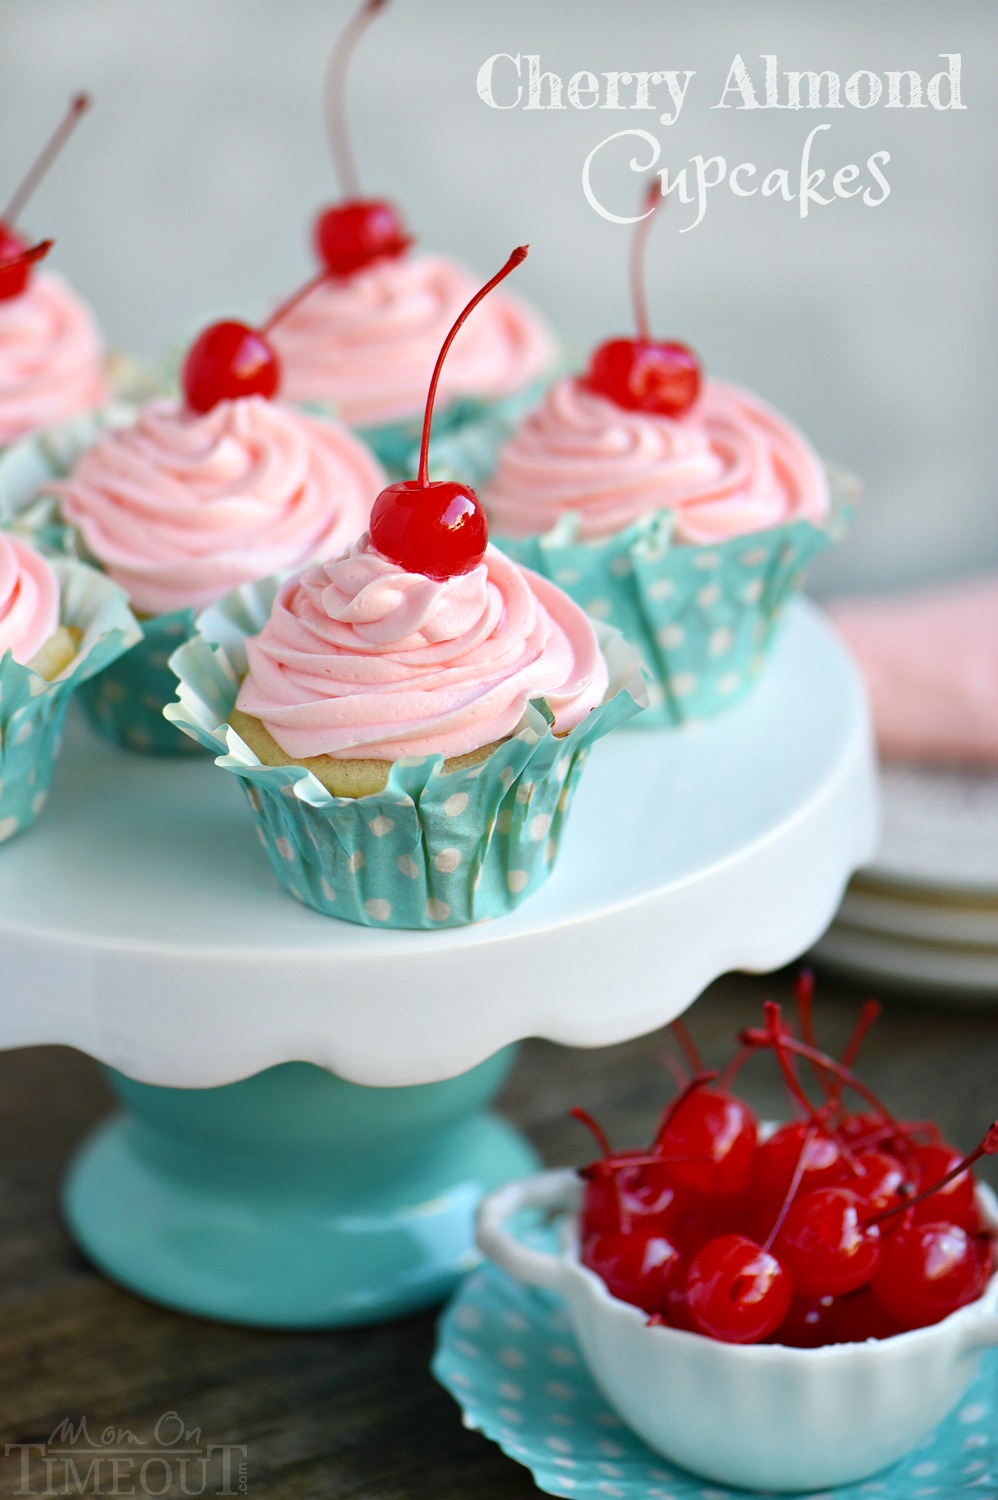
[482, 378, 830, 543]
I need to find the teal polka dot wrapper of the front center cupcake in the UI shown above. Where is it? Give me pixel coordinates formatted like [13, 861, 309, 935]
[165, 581, 645, 929]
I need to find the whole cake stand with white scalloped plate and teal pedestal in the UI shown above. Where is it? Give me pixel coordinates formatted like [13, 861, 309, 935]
[0, 605, 876, 1326]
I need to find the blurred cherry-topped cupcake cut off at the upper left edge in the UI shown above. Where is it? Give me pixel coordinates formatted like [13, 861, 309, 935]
[0, 95, 108, 449]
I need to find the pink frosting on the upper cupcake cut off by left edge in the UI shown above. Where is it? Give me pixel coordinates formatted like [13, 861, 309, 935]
[0, 272, 108, 443]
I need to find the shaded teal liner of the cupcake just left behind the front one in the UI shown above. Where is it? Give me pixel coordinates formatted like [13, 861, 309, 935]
[80, 609, 201, 755]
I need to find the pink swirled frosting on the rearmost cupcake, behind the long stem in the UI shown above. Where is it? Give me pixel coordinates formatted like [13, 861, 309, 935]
[269, 255, 554, 428]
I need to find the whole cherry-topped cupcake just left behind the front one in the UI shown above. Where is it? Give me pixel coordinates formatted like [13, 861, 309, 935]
[44, 300, 384, 753]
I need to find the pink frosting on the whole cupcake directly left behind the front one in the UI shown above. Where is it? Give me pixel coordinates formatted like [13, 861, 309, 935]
[54, 396, 386, 615]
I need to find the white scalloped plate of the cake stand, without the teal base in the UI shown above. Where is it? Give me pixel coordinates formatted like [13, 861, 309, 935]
[0, 605, 876, 1088]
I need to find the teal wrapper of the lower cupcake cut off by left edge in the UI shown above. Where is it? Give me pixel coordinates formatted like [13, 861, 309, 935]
[0, 558, 141, 843]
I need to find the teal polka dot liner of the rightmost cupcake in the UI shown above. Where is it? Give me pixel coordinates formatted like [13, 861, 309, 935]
[495, 474, 857, 729]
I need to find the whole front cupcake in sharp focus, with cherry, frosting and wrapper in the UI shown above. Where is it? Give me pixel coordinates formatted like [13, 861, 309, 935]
[165, 249, 644, 929]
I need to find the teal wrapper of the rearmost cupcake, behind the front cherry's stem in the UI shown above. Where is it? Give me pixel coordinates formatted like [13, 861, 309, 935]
[357, 375, 554, 485]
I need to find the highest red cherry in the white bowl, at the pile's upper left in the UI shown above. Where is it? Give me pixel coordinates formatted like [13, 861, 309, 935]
[654, 1076, 758, 1197]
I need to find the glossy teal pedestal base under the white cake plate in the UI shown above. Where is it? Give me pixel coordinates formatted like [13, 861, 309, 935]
[65, 1049, 536, 1328]
